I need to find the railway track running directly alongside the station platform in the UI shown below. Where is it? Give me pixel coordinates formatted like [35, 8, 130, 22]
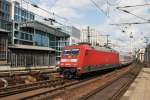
[79, 63, 141, 100]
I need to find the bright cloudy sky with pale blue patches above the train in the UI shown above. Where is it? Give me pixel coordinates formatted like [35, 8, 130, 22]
[16, 0, 150, 52]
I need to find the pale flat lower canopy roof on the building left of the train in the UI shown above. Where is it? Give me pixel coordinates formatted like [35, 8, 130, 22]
[9, 44, 56, 51]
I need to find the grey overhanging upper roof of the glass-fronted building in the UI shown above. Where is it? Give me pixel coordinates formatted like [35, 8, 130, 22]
[20, 21, 70, 37]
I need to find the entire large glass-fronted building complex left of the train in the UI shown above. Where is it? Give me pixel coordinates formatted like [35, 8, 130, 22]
[0, 0, 69, 67]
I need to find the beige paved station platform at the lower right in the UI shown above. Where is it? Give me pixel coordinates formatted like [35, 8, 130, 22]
[120, 68, 150, 100]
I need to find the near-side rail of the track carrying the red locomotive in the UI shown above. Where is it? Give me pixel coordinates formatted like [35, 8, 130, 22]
[21, 66, 131, 100]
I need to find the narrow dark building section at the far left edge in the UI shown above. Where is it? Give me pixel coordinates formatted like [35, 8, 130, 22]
[0, 0, 12, 65]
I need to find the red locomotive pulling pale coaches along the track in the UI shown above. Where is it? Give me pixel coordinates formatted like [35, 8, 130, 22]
[59, 44, 132, 78]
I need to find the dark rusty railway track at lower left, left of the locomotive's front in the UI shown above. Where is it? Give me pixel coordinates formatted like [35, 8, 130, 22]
[0, 79, 66, 97]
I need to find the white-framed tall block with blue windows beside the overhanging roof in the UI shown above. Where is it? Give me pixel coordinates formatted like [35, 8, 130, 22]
[12, 1, 35, 45]
